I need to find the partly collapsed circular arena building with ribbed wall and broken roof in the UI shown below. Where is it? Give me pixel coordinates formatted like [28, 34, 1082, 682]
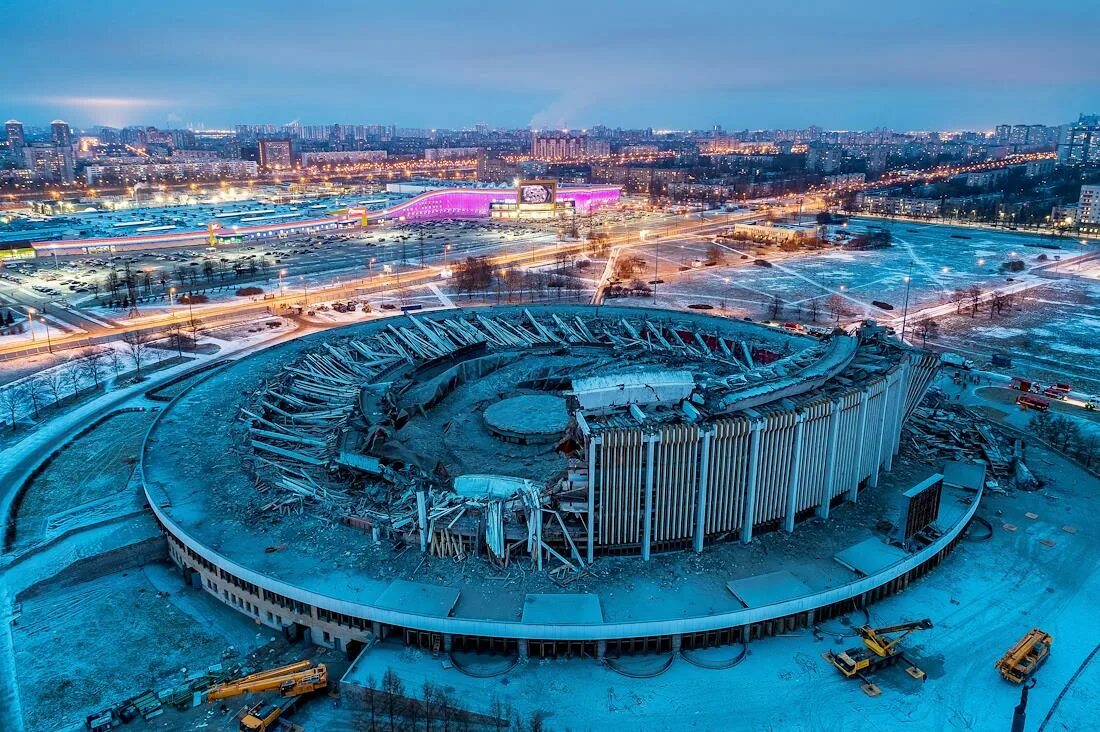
[141, 306, 978, 657]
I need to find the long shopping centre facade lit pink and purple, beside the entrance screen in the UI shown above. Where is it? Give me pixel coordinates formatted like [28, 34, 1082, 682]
[31, 186, 622, 256]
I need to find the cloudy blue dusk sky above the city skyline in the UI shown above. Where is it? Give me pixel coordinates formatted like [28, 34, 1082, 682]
[0, 0, 1100, 130]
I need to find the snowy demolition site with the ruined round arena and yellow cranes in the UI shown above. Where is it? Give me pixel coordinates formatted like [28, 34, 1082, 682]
[0, 230, 1100, 732]
